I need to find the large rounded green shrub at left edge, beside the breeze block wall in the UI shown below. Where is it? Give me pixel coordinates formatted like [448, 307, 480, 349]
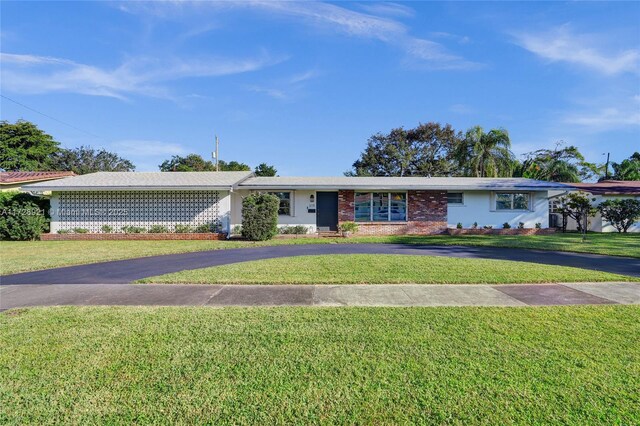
[0, 192, 49, 241]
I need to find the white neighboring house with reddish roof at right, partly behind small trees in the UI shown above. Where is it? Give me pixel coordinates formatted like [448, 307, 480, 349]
[549, 180, 640, 232]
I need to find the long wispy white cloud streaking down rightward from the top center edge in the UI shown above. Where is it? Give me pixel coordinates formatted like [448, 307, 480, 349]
[123, 1, 479, 69]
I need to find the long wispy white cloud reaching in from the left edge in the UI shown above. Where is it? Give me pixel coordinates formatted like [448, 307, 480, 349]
[0, 52, 285, 100]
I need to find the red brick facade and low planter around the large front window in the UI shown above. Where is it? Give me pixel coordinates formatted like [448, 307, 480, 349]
[338, 190, 447, 235]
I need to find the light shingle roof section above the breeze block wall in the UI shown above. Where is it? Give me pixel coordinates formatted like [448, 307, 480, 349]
[23, 172, 253, 191]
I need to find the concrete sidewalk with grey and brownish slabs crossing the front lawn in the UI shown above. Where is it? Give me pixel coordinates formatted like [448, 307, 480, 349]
[0, 283, 640, 310]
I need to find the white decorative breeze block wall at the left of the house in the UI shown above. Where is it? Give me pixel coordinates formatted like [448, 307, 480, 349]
[52, 191, 229, 233]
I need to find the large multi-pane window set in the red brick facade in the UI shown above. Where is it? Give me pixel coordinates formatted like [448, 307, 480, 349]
[354, 192, 407, 222]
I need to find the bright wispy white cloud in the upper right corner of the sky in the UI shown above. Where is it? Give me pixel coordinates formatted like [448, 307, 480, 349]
[515, 25, 640, 75]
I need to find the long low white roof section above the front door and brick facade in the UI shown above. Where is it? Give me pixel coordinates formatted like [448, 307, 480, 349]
[239, 176, 570, 191]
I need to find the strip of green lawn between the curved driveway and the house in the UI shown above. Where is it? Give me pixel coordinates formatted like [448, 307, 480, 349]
[0, 234, 640, 274]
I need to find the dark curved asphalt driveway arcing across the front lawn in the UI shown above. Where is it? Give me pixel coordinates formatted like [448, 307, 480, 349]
[0, 244, 640, 286]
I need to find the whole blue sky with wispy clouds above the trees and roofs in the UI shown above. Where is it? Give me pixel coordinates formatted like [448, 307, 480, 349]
[0, 1, 640, 175]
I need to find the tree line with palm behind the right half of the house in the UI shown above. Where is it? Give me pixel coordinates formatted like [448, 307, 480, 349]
[345, 122, 640, 182]
